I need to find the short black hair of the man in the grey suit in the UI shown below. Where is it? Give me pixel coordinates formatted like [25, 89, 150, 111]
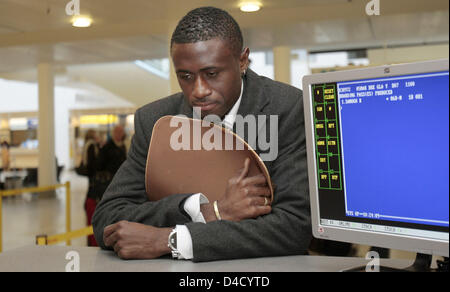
[170, 7, 244, 56]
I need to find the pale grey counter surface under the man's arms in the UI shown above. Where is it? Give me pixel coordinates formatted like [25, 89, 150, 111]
[0, 246, 412, 272]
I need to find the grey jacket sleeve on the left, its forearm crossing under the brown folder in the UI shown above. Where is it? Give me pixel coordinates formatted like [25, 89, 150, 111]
[92, 107, 190, 248]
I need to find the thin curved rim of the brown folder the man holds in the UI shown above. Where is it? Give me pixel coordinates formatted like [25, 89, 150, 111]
[145, 115, 274, 202]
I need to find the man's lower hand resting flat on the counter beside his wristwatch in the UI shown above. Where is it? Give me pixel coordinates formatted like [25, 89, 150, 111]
[103, 221, 172, 259]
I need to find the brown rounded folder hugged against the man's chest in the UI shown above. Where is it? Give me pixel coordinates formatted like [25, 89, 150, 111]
[145, 116, 273, 202]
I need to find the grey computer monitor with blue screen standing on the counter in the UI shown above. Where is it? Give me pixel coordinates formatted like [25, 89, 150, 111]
[303, 60, 449, 266]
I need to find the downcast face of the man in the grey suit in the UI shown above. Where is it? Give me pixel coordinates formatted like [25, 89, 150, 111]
[171, 38, 249, 118]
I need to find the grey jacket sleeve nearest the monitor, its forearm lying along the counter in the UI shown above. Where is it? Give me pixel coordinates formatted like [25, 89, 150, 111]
[186, 90, 311, 262]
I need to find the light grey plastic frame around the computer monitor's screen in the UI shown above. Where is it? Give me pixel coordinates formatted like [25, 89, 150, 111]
[303, 59, 449, 257]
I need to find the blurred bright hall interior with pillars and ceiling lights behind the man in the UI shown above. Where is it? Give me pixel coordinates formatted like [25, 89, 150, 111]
[0, 0, 449, 259]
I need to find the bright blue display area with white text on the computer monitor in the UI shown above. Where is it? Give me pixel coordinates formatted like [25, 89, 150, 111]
[336, 71, 449, 227]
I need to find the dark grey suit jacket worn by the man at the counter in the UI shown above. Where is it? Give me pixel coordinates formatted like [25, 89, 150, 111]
[93, 70, 311, 262]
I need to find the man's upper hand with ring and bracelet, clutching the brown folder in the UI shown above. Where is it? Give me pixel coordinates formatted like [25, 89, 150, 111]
[201, 158, 272, 222]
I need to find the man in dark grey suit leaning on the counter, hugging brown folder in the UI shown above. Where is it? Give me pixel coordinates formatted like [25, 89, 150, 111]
[93, 7, 311, 262]
